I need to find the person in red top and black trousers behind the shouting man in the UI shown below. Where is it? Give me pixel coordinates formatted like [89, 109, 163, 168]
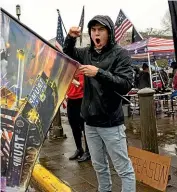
[67, 74, 90, 162]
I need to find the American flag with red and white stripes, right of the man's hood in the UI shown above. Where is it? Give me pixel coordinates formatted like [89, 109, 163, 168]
[115, 9, 132, 43]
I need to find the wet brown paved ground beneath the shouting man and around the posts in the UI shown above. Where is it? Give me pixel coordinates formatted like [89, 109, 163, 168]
[32, 117, 177, 192]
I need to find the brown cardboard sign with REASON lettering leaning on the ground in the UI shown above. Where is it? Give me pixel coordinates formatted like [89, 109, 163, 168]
[128, 147, 171, 191]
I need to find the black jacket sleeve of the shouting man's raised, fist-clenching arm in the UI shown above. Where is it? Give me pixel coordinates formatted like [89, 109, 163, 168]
[63, 35, 85, 64]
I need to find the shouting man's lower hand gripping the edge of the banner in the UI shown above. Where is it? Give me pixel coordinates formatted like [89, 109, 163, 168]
[79, 65, 99, 77]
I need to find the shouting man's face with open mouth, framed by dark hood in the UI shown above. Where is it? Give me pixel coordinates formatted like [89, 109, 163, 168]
[91, 23, 108, 49]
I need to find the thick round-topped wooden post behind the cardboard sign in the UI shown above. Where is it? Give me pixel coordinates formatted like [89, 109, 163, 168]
[138, 88, 159, 154]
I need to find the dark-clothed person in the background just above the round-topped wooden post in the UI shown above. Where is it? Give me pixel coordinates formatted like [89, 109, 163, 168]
[138, 63, 151, 89]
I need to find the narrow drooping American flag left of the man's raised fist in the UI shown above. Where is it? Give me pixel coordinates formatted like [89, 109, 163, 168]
[55, 11, 64, 51]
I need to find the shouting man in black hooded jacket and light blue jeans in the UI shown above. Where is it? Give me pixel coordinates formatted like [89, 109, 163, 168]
[63, 15, 136, 192]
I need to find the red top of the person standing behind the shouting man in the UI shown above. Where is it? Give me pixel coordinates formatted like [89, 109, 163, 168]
[67, 74, 84, 99]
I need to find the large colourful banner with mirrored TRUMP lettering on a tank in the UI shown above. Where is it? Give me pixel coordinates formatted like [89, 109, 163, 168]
[0, 9, 79, 192]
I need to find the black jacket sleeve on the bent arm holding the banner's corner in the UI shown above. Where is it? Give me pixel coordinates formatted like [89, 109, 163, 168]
[95, 49, 133, 95]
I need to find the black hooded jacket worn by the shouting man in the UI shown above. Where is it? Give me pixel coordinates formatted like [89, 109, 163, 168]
[63, 15, 133, 127]
